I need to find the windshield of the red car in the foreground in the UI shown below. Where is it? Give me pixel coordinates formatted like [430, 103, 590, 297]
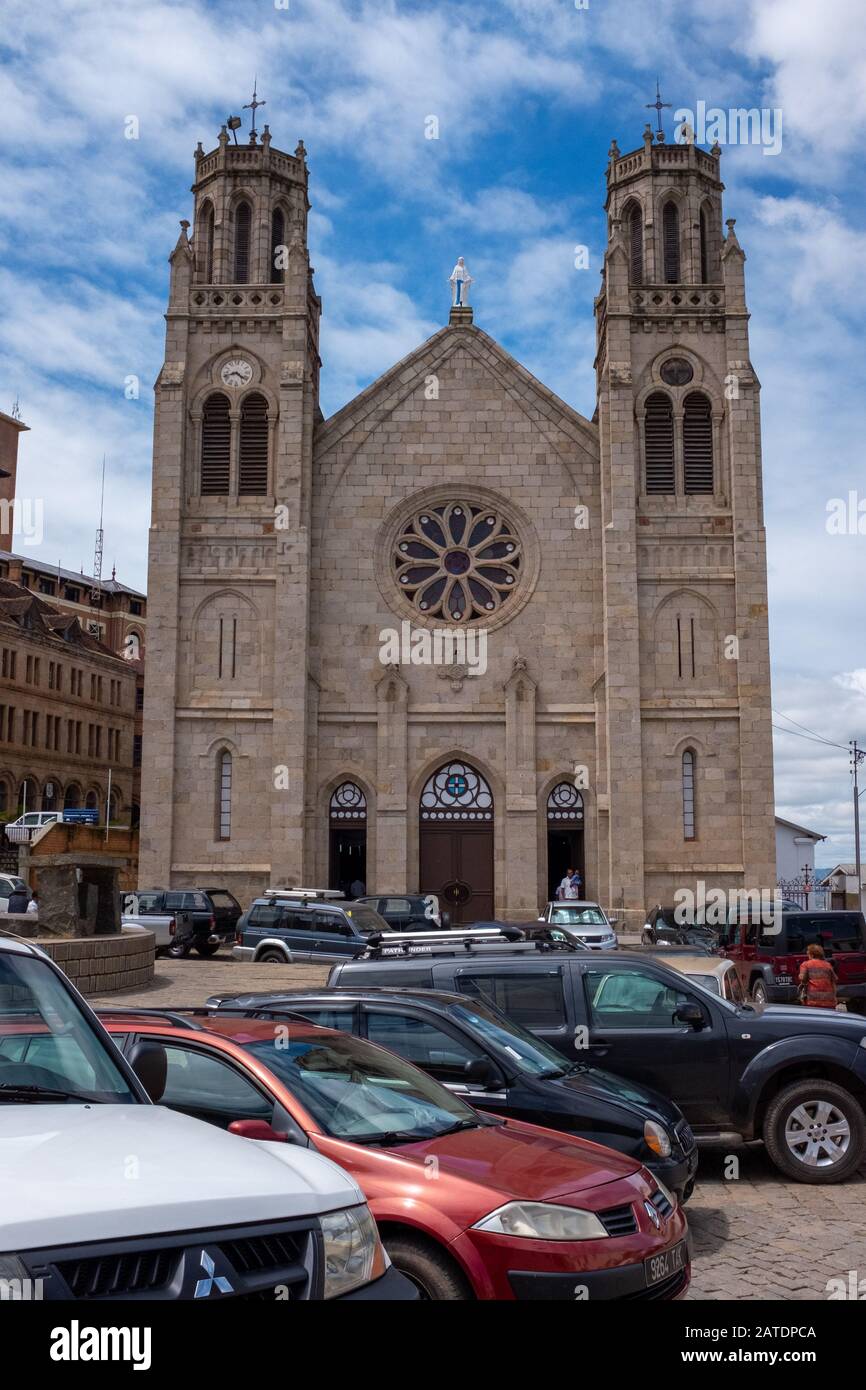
[245, 1024, 481, 1144]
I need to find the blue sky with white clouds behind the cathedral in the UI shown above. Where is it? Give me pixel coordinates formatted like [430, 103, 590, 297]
[0, 0, 866, 863]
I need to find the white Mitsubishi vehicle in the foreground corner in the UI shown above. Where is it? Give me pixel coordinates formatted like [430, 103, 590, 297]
[0, 935, 417, 1301]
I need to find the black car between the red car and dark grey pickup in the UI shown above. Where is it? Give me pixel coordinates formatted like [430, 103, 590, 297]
[207, 988, 698, 1201]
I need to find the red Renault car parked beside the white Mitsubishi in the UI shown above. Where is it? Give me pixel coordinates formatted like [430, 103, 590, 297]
[101, 1011, 691, 1300]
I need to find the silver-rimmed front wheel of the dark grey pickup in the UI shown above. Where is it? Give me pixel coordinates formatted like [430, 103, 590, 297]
[763, 1080, 866, 1183]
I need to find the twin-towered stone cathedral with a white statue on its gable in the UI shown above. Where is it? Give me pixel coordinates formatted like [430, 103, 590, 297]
[140, 126, 776, 922]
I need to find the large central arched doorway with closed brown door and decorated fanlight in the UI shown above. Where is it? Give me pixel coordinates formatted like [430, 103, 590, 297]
[418, 760, 493, 926]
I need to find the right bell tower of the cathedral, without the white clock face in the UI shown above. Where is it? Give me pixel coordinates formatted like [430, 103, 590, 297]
[595, 125, 776, 912]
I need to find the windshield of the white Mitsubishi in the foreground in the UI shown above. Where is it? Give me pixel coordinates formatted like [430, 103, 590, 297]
[0, 951, 140, 1104]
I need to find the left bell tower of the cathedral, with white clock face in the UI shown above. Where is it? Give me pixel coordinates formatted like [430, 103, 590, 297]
[140, 119, 321, 897]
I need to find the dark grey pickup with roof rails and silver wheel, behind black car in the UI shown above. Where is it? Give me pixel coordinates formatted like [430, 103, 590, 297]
[328, 948, 866, 1183]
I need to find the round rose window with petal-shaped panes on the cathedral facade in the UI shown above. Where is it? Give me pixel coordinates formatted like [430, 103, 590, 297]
[393, 502, 521, 623]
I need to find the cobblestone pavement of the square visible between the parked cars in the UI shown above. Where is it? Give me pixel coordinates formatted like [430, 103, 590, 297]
[90, 952, 866, 1301]
